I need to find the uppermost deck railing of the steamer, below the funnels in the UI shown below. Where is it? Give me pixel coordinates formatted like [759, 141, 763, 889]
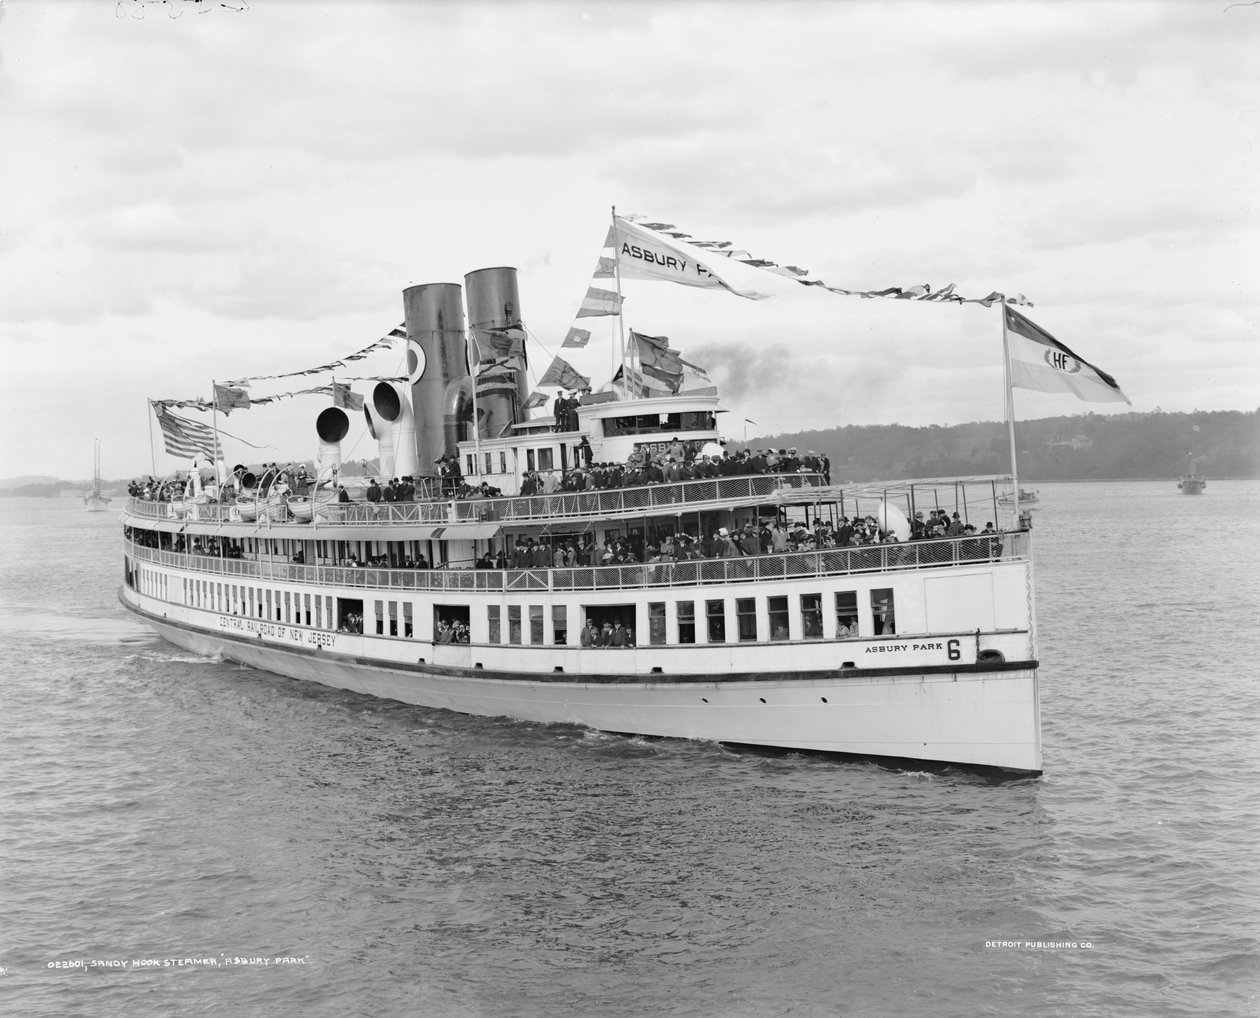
[127, 474, 824, 528]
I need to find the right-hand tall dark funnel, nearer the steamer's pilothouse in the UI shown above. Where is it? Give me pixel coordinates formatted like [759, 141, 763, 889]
[464, 267, 529, 438]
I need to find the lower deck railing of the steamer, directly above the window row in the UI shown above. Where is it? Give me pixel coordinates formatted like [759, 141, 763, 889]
[127, 532, 1029, 591]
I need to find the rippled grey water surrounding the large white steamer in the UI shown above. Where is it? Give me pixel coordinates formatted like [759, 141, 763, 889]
[0, 481, 1260, 1018]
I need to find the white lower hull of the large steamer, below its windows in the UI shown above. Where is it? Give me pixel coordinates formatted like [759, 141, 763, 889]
[121, 588, 1042, 774]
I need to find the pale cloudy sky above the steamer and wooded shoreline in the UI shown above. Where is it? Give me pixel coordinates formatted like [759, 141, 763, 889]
[0, 0, 1260, 479]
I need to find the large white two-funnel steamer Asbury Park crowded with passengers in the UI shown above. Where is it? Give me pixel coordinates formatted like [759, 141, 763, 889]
[120, 210, 1123, 775]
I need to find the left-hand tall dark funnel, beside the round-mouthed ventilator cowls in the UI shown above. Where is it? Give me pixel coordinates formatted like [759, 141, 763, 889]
[402, 282, 469, 475]
